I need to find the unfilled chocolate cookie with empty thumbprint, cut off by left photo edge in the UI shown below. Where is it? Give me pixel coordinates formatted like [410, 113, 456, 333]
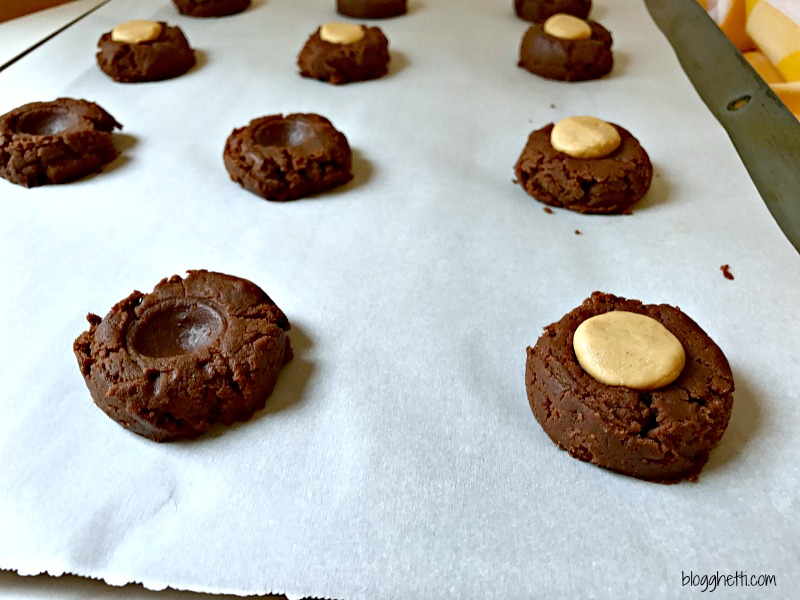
[0, 98, 122, 187]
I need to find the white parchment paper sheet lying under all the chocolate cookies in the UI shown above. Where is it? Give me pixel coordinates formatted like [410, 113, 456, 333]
[0, 0, 800, 599]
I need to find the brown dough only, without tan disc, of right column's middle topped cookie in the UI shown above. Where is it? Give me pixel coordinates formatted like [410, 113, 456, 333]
[514, 123, 653, 214]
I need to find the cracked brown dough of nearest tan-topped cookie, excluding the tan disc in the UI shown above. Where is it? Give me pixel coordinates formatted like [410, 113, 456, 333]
[525, 292, 734, 483]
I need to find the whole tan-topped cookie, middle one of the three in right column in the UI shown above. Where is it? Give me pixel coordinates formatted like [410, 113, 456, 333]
[514, 117, 653, 214]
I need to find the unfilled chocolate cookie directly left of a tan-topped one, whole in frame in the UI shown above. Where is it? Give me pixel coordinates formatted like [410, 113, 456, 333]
[223, 114, 353, 201]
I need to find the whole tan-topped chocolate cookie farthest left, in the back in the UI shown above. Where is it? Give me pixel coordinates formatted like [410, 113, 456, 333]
[97, 21, 195, 83]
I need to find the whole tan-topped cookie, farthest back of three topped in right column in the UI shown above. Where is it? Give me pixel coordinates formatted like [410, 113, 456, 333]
[518, 14, 614, 81]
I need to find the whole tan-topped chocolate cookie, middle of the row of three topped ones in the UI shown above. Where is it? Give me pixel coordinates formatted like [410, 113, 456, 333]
[297, 23, 390, 85]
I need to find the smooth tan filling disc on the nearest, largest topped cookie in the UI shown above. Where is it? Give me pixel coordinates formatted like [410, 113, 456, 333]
[572, 311, 686, 390]
